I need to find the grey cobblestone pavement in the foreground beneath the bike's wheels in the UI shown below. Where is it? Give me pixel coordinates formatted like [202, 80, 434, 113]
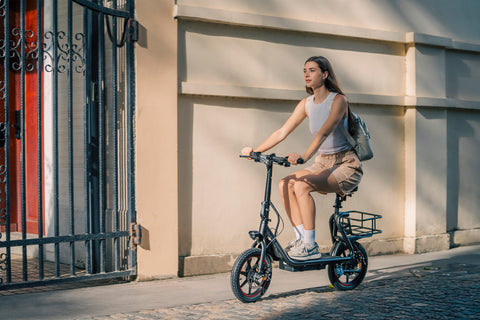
[81, 264, 480, 320]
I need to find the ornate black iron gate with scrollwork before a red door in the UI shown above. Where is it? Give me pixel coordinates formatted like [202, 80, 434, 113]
[0, 0, 138, 289]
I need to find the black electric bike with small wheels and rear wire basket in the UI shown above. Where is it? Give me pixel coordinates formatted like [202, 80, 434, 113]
[230, 152, 382, 302]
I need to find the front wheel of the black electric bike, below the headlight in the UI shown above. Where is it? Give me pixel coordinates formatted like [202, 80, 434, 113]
[230, 248, 272, 302]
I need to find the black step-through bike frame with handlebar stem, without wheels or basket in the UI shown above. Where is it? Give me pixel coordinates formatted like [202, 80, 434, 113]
[249, 155, 355, 270]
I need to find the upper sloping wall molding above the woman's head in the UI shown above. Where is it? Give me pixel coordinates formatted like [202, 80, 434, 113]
[173, 5, 480, 53]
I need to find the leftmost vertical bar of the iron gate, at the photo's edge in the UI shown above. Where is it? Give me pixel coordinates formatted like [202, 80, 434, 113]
[3, 1, 12, 283]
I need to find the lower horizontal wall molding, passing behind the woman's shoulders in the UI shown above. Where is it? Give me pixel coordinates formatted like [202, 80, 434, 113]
[178, 82, 480, 110]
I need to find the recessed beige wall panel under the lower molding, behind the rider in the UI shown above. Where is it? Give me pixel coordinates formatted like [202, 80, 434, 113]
[179, 97, 404, 256]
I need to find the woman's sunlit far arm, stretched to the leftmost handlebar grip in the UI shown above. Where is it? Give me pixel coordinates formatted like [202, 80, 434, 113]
[242, 98, 307, 155]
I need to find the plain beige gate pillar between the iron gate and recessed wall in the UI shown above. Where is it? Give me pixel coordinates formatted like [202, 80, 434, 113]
[135, 1, 178, 279]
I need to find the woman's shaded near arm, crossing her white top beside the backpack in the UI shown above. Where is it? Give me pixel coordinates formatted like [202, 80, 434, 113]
[302, 94, 348, 162]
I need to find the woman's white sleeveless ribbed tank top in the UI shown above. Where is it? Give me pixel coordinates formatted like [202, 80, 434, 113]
[305, 92, 352, 154]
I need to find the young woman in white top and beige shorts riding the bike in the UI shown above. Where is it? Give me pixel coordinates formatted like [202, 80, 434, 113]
[242, 56, 363, 260]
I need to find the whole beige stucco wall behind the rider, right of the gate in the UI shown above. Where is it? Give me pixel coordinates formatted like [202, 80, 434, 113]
[137, 0, 480, 275]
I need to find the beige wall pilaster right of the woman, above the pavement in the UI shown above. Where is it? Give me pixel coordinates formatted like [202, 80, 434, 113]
[404, 45, 450, 253]
